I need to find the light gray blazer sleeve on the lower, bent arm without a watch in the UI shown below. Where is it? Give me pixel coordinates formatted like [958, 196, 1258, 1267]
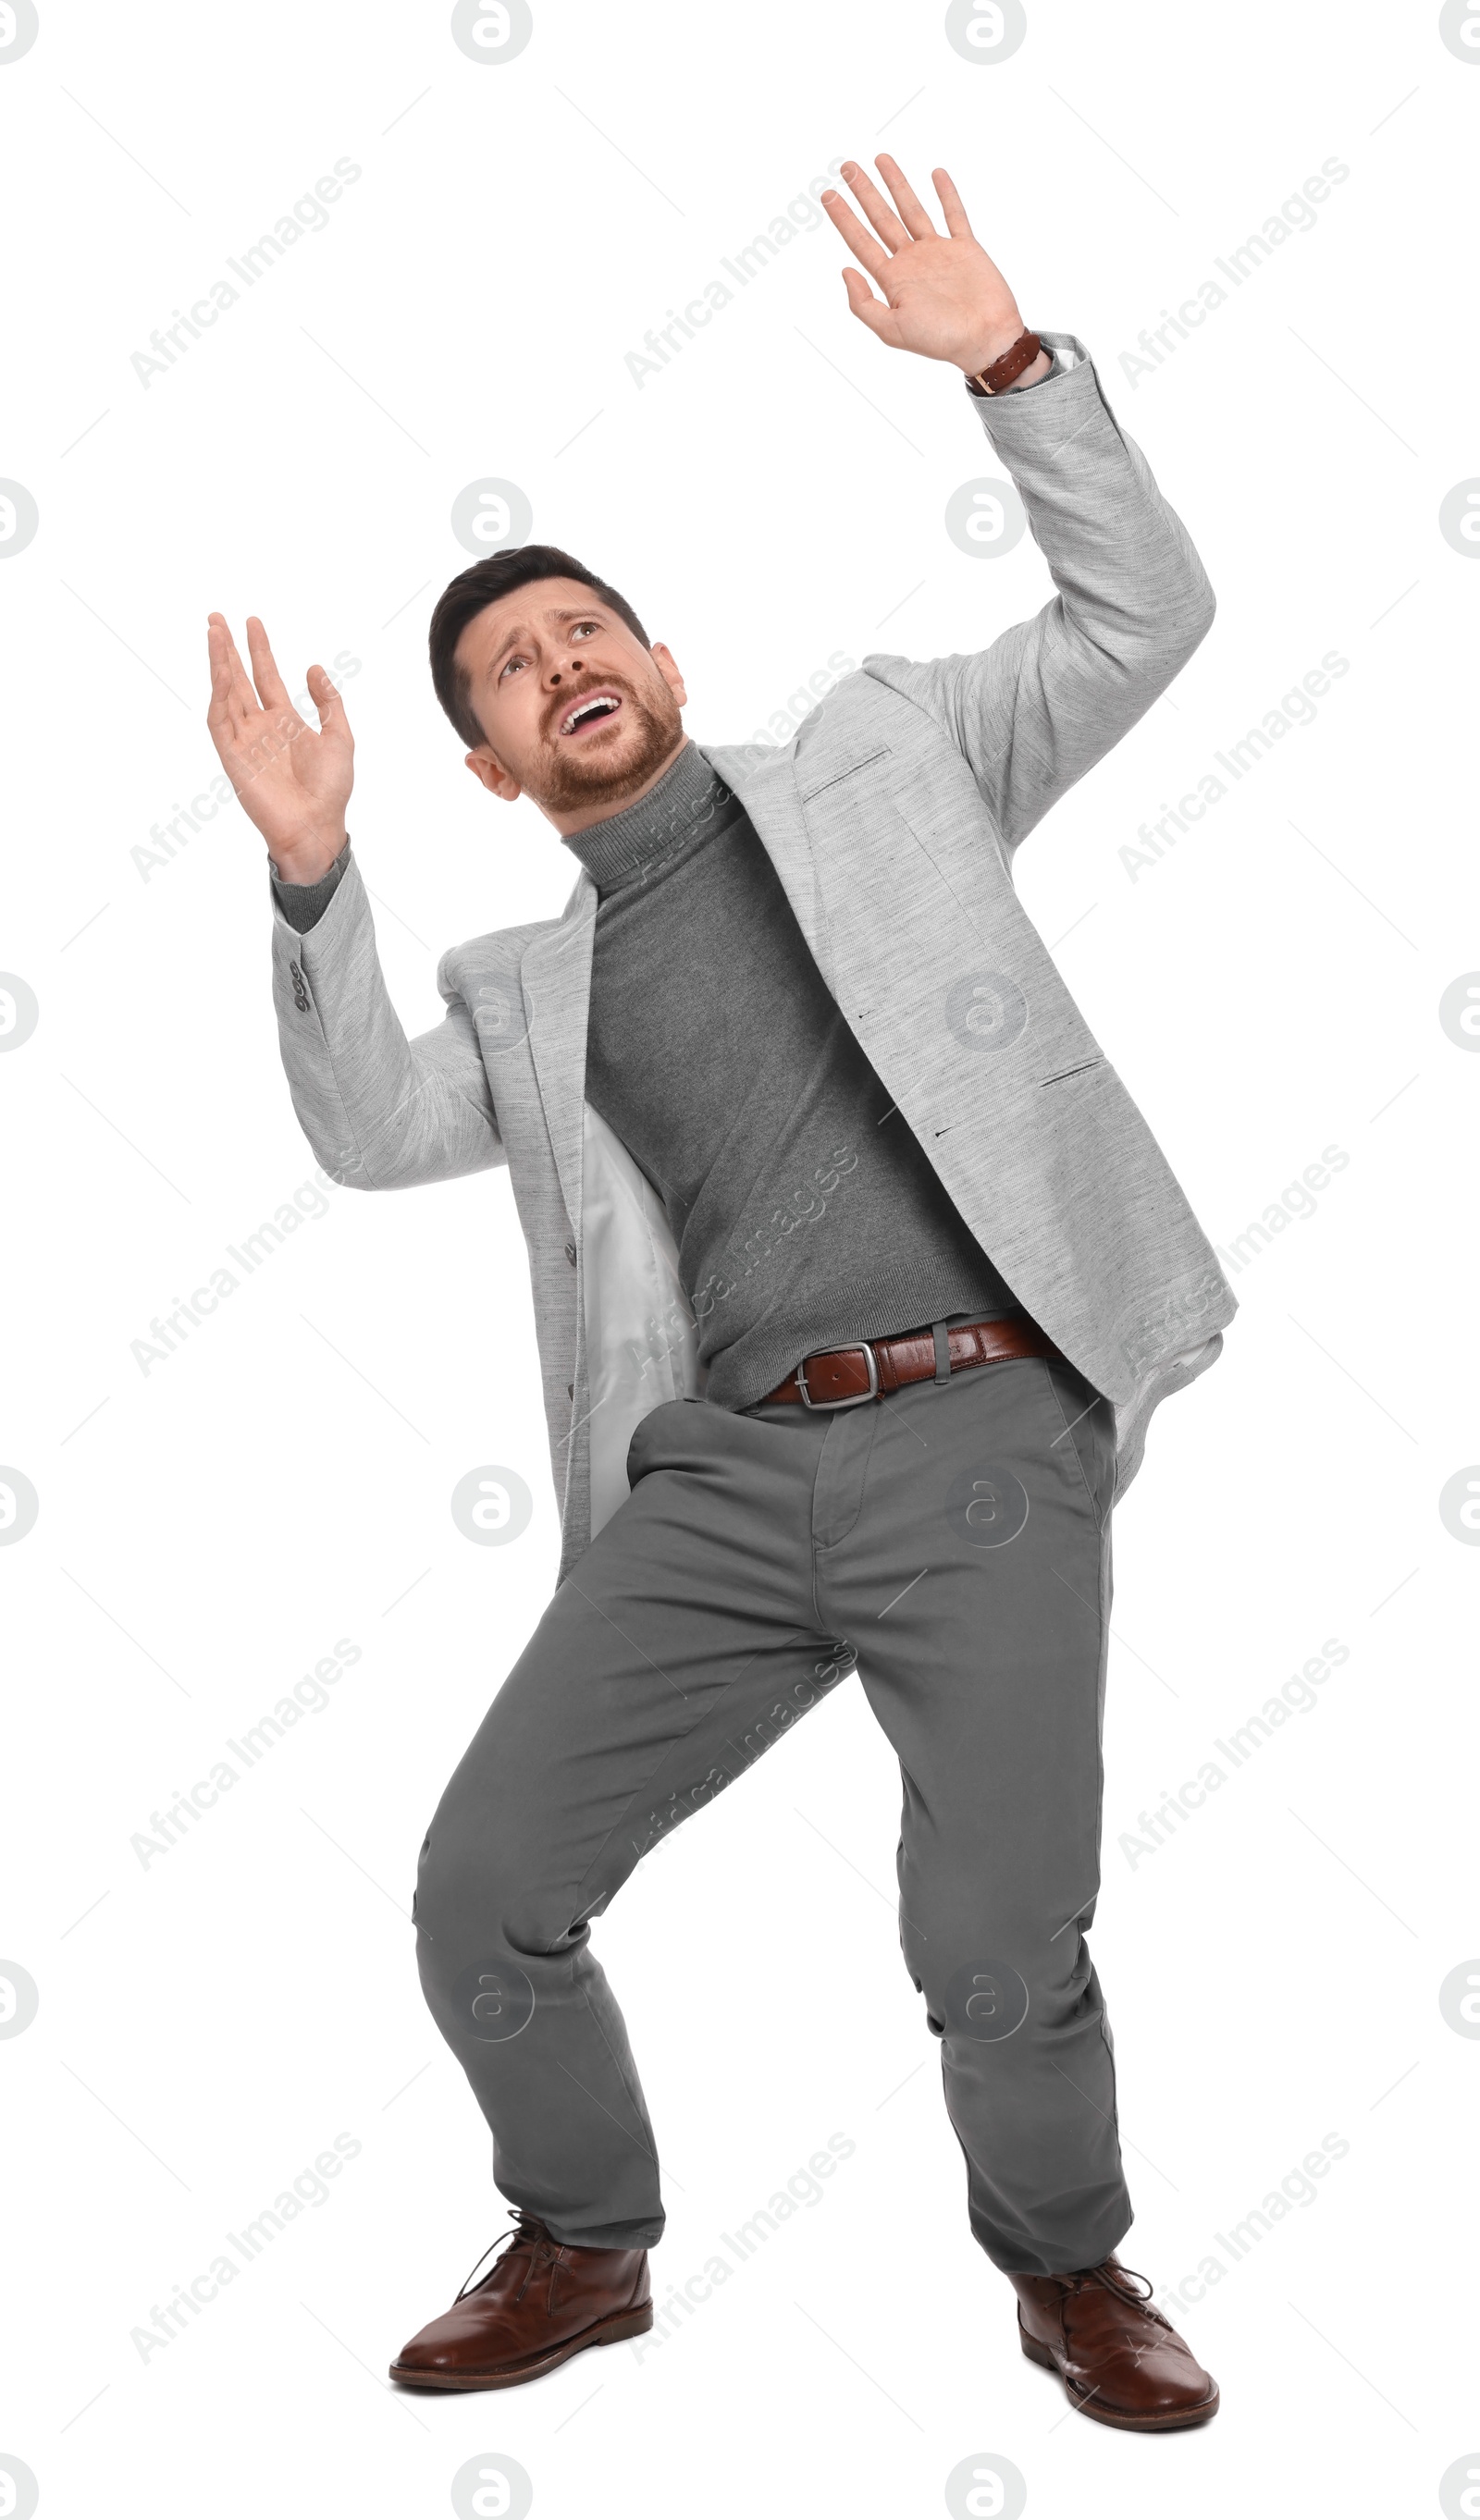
[272, 854, 507, 1189]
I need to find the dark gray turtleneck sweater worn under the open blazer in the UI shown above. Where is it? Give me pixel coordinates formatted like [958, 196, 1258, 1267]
[278, 744, 1021, 1408]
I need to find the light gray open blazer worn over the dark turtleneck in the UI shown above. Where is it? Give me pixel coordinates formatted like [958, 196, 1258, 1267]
[272, 333, 1238, 1582]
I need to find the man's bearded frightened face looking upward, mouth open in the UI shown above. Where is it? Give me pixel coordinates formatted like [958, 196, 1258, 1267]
[456, 577, 688, 831]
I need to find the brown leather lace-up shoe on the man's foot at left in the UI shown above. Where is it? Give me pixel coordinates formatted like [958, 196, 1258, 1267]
[390, 2210, 653, 2389]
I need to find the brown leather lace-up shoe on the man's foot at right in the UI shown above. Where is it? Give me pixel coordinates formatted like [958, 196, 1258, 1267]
[1011, 2253, 1218, 2432]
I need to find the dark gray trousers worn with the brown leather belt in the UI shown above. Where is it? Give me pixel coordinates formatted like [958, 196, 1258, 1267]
[413, 1358, 1132, 2276]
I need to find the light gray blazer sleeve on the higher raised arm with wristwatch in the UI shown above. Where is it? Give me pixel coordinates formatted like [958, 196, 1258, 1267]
[865, 333, 1215, 857]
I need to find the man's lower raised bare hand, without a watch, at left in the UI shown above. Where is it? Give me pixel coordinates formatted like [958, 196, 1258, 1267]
[207, 612, 355, 884]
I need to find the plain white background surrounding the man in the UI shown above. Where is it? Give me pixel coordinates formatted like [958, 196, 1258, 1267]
[0, 0, 1480, 2520]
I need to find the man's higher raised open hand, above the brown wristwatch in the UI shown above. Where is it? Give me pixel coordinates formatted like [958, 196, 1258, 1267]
[822, 156, 1021, 371]
